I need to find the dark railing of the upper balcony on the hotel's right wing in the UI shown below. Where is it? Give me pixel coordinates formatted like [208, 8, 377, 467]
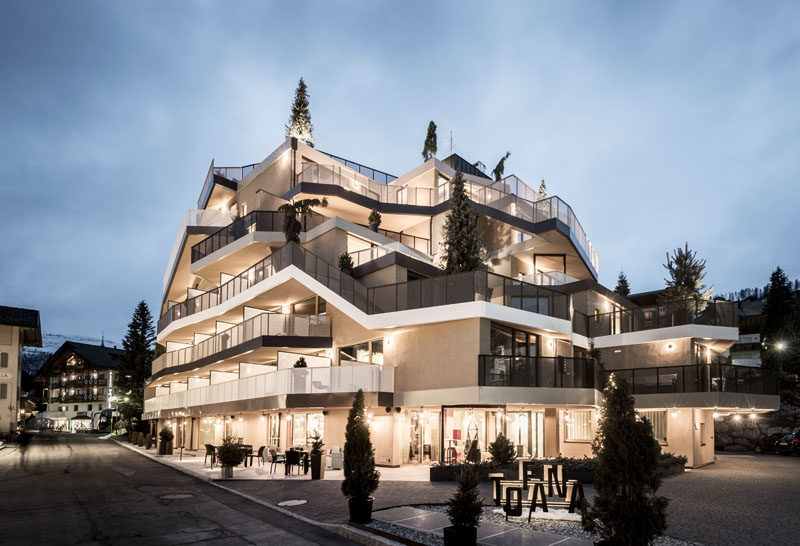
[572, 300, 739, 337]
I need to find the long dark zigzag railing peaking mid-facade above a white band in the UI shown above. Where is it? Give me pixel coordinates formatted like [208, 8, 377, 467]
[158, 243, 569, 332]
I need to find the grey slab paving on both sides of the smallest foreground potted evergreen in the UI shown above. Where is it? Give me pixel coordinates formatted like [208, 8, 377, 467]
[372, 506, 592, 546]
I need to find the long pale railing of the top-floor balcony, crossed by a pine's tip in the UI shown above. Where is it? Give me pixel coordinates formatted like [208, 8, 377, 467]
[297, 163, 599, 271]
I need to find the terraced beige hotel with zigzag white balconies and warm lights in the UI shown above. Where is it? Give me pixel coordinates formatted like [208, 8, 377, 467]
[144, 139, 779, 466]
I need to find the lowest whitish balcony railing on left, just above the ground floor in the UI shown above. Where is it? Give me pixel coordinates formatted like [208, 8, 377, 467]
[144, 365, 394, 415]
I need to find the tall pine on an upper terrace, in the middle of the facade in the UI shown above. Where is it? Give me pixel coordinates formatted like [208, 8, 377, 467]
[443, 171, 484, 273]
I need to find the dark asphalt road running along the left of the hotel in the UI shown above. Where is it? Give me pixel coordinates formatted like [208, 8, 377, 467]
[0, 435, 351, 546]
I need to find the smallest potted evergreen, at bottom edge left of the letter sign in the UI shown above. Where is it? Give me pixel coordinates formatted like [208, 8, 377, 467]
[443, 464, 483, 546]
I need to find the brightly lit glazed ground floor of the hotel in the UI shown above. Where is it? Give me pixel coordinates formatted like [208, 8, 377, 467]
[153, 398, 732, 466]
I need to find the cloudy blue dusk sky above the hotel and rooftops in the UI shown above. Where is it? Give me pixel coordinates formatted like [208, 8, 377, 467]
[0, 1, 800, 340]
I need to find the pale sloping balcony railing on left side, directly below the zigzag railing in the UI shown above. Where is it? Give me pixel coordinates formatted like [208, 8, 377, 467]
[152, 313, 331, 375]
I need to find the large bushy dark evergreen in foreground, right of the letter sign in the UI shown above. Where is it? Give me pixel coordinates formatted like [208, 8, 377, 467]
[582, 374, 669, 545]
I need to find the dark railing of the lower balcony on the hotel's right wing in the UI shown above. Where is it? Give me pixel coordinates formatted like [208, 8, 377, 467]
[605, 364, 778, 395]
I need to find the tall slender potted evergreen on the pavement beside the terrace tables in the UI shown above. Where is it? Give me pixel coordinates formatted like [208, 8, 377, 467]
[342, 389, 380, 523]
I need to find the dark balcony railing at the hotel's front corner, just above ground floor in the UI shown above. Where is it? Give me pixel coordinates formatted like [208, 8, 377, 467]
[478, 355, 601, 389]
